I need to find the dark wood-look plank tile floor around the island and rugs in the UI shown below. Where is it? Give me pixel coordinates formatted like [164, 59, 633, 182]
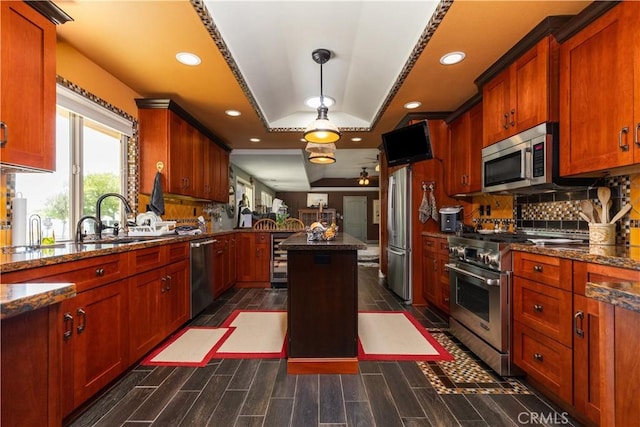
[68, 267, 577, 427]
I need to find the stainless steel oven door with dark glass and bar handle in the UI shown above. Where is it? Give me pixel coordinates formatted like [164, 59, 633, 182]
[447, 262, 509, 353]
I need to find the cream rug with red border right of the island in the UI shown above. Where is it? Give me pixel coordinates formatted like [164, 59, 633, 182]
[358, 311, 453, 361]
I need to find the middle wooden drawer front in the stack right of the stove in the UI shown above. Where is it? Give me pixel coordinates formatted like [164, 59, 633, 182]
[513, 277, 573, 347]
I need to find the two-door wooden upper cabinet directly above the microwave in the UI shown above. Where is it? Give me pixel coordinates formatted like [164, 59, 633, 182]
[482, 36, 558, 147]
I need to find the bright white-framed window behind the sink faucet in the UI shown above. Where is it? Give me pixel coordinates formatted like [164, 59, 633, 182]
[15, 86, 132, 241]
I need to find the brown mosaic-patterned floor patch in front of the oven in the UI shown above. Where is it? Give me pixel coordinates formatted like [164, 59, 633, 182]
[417, 329, 531, 394]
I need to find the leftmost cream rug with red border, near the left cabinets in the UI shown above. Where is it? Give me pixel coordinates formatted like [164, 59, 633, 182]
[142, 327, 232, 366]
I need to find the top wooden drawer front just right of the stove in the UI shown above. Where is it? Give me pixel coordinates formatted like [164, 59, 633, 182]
[513, 252, 572, 291]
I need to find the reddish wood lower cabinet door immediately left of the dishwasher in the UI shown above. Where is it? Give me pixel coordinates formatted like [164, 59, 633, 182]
[160, 260, 190, 336]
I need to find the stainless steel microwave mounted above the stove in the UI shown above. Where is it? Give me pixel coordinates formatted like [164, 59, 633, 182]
[482, 123, 592, 194]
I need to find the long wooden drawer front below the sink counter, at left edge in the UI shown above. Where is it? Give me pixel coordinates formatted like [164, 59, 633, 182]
[2, 254, 127, 293]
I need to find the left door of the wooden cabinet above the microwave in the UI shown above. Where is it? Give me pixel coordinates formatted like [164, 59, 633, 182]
[482, 68, 510, 147]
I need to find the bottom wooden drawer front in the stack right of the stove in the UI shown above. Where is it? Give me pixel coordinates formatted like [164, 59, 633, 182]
[513, 322, 573, 403]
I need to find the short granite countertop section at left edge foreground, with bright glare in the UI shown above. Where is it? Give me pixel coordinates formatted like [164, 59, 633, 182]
[0, 283, 76, 319]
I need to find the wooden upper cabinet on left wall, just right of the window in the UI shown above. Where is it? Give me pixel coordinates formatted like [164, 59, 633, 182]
[136, 99, 229, 203]
